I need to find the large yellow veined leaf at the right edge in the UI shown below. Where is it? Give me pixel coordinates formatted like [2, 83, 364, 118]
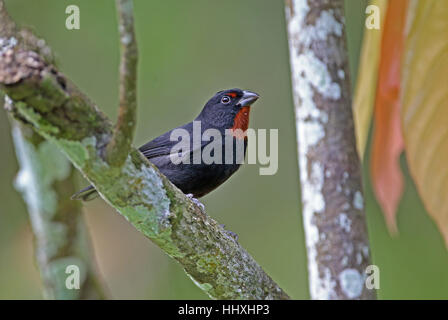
[400, 0, 448, 246]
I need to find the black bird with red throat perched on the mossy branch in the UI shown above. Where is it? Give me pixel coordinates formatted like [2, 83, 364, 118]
[72, 88, 259, 201]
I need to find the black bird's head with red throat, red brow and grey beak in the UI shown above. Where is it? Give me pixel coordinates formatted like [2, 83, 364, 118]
[196, 88, 259, 131]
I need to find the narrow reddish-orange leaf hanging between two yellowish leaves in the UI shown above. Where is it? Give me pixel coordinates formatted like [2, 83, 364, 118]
[371, 0, 408, 233]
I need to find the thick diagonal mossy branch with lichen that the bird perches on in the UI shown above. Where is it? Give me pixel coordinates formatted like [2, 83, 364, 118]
[0, 1, 289, 299]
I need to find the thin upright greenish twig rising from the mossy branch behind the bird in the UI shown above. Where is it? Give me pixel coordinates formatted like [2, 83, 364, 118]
[106, 0, 138, 166]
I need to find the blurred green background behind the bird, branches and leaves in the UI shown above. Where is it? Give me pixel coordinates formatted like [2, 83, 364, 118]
[0, 0, 448, 299]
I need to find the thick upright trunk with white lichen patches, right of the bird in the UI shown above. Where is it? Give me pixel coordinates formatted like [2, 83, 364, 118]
[286, 0, 375, 299]
